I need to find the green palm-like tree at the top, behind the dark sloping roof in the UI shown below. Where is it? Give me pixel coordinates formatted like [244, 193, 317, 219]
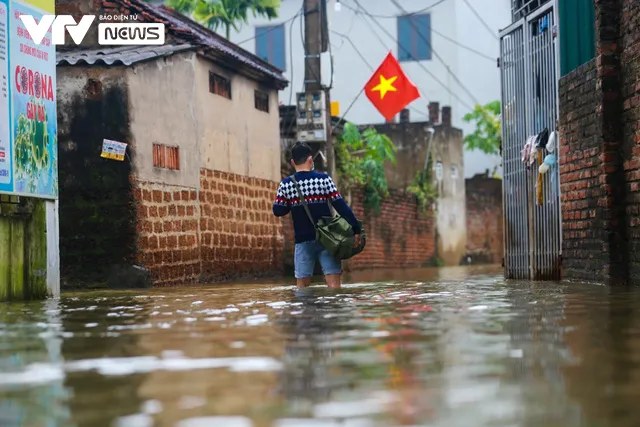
[166, 0, 280, 39]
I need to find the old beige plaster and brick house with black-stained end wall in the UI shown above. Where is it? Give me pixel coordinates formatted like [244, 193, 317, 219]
[57, 0, 288, 285]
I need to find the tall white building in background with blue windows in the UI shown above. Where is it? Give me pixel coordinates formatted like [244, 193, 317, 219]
[225, 0, 515, 178]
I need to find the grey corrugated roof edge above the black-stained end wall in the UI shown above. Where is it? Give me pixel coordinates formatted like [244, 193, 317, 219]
[56, 44, 195, 65]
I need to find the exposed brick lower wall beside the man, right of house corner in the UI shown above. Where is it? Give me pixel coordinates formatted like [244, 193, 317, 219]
[200, 169, 284, 280]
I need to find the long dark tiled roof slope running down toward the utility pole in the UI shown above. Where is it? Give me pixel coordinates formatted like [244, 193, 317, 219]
[92, 0, 288, 89]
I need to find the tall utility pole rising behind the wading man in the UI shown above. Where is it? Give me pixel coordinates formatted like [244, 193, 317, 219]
[298, 0, 335, 178]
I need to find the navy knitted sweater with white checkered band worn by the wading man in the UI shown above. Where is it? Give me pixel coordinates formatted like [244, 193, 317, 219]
[273, 171, 361, 243]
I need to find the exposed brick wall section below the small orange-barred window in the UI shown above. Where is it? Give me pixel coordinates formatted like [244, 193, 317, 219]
[134, 182, 200, 286]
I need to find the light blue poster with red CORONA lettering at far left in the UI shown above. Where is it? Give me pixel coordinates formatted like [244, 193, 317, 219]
[0, 0, 58, 199]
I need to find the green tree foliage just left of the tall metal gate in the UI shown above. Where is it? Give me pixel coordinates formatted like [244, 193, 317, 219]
[463, 101, 502, 154]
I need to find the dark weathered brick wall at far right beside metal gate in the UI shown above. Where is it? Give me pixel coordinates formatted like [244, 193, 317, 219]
[559, 0, 640, 284]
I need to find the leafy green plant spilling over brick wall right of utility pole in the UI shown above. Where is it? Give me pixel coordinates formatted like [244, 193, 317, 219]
[334, 123, 397, 214]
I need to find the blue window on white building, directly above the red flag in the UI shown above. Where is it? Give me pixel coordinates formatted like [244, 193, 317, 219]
[398, 14, 431, 61]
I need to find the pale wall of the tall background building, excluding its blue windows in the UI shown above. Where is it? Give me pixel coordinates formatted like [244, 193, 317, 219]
[231, 0, 511, 177]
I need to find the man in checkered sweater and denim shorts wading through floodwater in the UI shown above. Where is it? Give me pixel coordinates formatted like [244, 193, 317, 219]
[273, 142, 361, 288]
